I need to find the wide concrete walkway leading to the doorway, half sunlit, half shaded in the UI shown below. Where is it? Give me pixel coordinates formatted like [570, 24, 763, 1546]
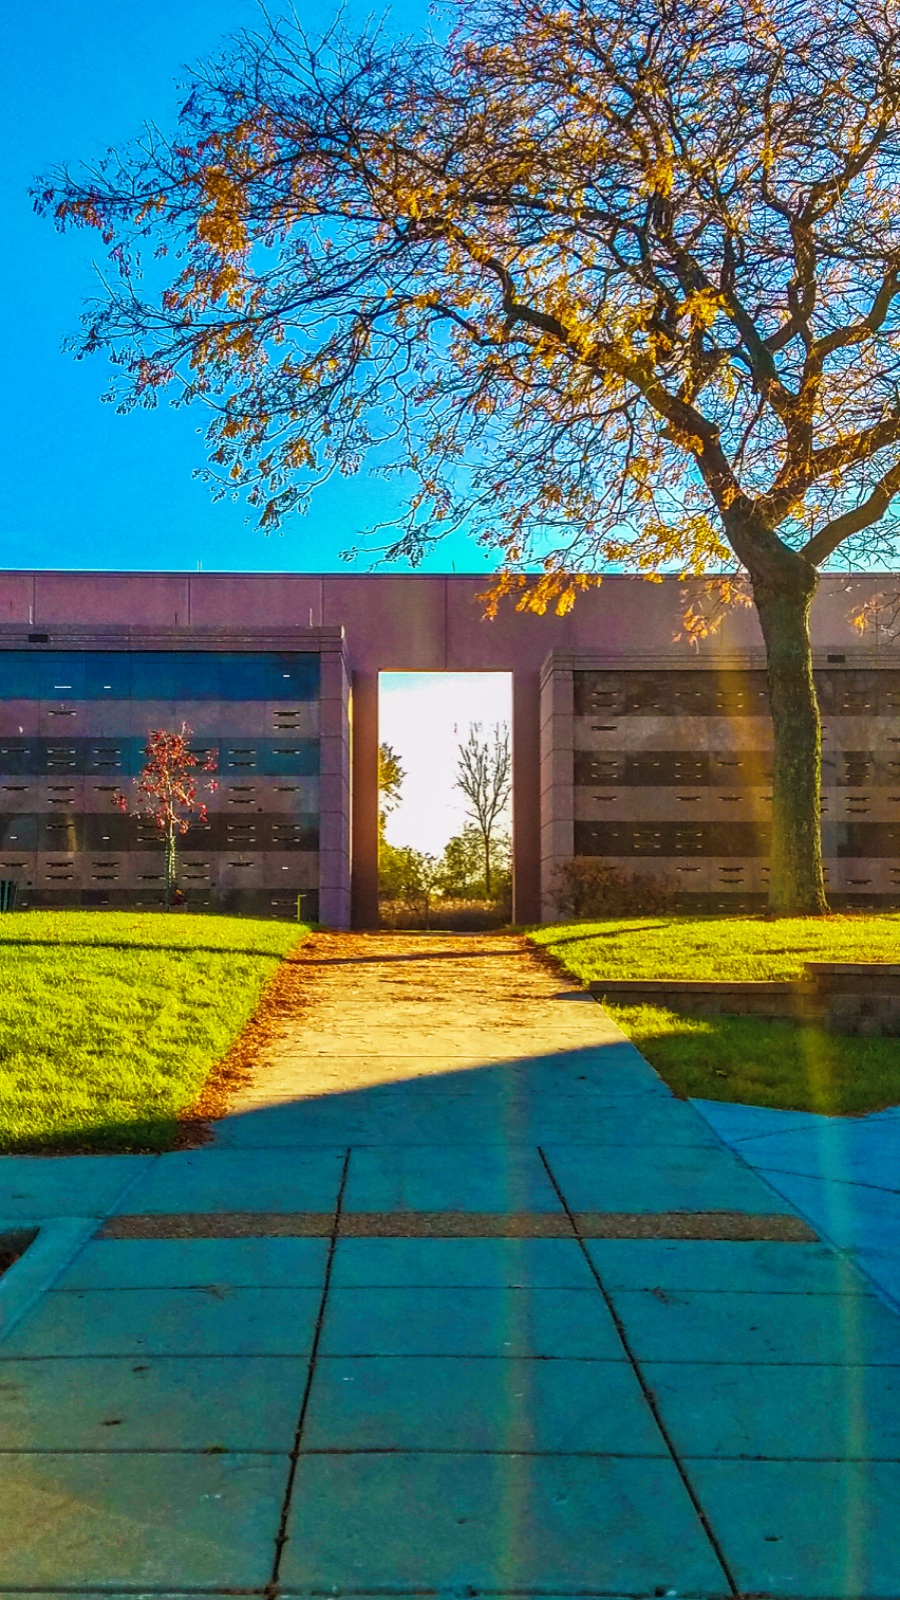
[0, 934, 900, 1600]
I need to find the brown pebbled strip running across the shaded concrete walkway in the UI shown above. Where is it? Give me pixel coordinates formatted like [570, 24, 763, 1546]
[96, 1210, 818, 1245]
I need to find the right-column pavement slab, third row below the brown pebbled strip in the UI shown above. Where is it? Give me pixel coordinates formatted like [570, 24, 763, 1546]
[642, 1362, 900, 1461]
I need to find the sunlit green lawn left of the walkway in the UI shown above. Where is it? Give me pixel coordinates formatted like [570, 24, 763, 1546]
[0, 910, 306, 1152]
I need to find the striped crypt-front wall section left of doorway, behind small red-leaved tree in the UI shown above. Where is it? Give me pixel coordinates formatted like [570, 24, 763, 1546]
[0, 629, 349, 926]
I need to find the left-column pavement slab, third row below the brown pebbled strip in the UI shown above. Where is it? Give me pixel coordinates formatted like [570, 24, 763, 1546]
[0, 1355, 307, 1453]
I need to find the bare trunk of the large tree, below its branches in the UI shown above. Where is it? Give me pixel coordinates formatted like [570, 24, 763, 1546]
[753, 552, 828, 917]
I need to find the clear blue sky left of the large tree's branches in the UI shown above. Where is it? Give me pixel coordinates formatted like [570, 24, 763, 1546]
[0, 0, 485, 571]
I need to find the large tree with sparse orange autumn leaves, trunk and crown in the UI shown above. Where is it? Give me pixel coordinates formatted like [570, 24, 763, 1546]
[38, 0, 900, 912]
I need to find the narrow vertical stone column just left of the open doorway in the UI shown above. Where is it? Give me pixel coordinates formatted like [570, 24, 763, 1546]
[312, 629, 351, 928]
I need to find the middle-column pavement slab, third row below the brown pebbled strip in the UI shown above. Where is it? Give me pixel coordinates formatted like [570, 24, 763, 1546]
[303, 1355, 668, 1458]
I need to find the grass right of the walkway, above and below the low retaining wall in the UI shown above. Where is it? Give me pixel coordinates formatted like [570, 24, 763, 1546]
[530, 915, 900, 1114]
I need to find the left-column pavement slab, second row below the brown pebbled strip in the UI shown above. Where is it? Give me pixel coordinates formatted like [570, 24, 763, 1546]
[0, 1285, 322, 1362]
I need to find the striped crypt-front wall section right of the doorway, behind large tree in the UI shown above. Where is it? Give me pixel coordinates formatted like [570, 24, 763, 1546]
[541, 648, 900, 914]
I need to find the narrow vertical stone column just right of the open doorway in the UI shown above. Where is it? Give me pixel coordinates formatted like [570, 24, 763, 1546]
[540, 654, 575, 922]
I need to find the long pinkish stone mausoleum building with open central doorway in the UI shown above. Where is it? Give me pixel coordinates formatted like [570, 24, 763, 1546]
[0, 571, 900, 926]
